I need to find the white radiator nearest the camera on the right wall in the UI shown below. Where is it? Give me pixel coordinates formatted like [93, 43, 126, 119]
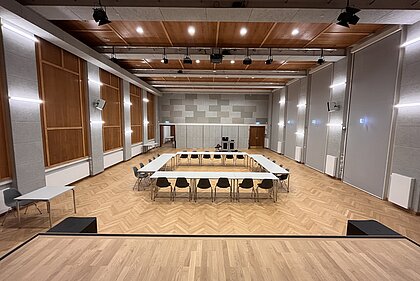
[388, 173, 415, 209]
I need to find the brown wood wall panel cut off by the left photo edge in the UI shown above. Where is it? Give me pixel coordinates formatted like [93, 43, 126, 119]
[0, 58, 11, 181]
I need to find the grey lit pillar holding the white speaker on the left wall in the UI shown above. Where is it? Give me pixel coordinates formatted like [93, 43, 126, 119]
[86, 62, 104, 175]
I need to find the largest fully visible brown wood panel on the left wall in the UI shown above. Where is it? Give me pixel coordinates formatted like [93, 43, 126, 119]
[37, 40, 88, 167]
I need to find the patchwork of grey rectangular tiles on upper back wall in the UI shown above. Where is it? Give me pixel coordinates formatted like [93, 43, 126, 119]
[159, 94, 268, 124]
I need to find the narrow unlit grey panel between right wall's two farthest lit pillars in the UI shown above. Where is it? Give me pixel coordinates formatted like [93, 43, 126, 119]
[284, 81, 300, 159]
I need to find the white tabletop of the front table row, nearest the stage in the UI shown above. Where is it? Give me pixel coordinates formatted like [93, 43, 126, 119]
[151, 171, 277, 180]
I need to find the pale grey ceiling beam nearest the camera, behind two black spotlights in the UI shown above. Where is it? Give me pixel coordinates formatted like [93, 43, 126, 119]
[28, 6, 420, 24]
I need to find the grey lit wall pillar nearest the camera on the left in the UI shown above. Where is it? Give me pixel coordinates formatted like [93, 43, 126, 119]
[0, 25, 45, 193]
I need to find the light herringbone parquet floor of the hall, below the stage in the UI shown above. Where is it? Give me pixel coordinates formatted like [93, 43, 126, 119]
[0, 148, 420, 254]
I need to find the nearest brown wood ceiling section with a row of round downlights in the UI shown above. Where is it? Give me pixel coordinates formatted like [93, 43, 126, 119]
[53, 21, 385, 48]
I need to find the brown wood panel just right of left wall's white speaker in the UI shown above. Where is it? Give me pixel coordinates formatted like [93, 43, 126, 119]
[99, 69, 123, 152]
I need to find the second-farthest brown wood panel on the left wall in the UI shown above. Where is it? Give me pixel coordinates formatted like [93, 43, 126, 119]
[130, 84, 143, 144]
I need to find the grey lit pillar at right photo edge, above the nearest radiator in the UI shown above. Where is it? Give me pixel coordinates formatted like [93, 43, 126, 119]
[392, 22, 420, 212]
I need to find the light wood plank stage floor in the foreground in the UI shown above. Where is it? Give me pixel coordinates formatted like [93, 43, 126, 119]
[0, 236, 420, 281]
